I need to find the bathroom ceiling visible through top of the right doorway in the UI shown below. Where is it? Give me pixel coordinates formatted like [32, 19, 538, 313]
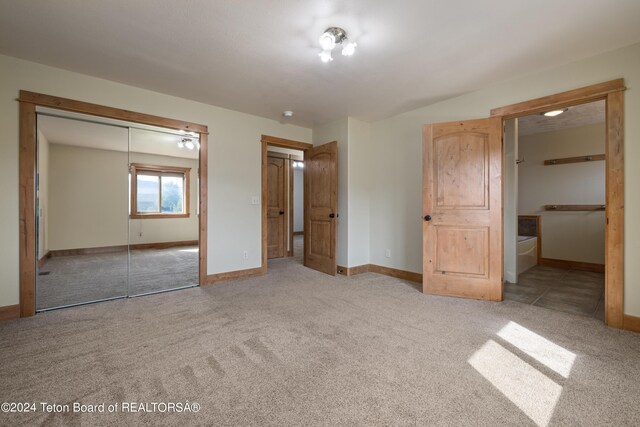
[518, 101, 605, 135]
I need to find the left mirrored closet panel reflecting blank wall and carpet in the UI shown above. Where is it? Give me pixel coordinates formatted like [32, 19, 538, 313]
[36, 114, 128, 311]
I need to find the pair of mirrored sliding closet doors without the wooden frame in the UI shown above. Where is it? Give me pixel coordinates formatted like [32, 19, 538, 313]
[36, 109, 199, 311]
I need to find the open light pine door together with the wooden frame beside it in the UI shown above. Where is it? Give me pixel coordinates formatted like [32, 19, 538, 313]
[422, 79, 634, 328]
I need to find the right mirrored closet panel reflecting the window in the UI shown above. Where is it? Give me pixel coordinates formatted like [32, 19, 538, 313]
[129, 128, 200, 296]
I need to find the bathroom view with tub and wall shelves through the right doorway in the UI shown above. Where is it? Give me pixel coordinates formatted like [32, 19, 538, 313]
[504, 100, 606, 321]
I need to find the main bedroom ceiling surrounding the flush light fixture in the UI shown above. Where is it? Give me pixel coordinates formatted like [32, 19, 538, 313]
[0, 0, 640, 126]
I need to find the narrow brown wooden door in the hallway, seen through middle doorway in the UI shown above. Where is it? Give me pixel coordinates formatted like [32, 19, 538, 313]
[267, 157, 286, 259]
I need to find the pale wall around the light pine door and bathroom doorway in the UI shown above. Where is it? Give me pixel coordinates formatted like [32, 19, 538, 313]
[370, 44, 640, 316]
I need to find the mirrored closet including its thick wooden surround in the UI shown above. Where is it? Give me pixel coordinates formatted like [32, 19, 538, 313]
[18, 91, 208, 317]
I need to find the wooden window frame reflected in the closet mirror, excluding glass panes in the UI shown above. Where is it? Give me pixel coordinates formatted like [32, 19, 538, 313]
[129, 163, 191, 219]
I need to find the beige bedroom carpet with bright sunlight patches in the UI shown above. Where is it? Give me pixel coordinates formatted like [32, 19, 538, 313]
[0, 252, 640, 426]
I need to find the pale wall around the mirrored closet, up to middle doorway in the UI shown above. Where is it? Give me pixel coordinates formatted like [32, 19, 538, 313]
[0, 55, 311, 307]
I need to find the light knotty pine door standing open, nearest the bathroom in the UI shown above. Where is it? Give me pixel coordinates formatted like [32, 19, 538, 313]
[422, 117, 503, 301]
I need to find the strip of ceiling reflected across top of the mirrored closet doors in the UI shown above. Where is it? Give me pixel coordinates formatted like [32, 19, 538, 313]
[38, 109, 198, 159]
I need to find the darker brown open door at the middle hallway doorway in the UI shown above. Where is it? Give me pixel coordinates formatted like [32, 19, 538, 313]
[304, 141, 338, 276]
